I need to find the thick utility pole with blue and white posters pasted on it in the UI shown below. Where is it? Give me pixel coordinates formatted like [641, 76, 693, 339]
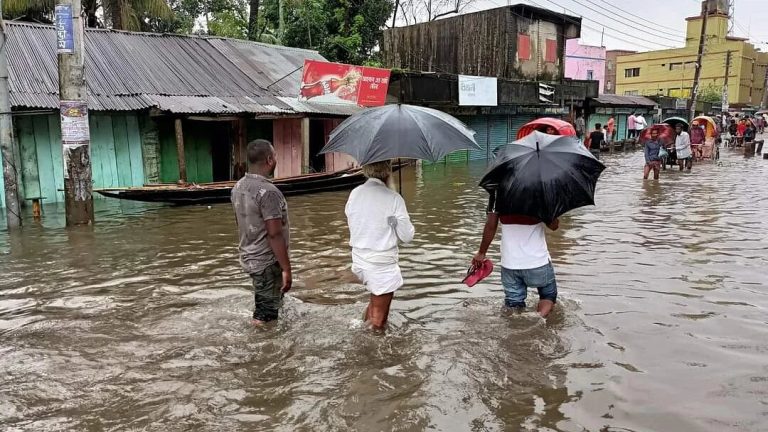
[55, 0, 93, 225]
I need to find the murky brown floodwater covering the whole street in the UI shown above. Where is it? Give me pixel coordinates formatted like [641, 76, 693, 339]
[0, 150, 768, 432]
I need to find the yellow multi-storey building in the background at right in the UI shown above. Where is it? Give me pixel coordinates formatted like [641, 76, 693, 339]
[616, 2, 768, 107]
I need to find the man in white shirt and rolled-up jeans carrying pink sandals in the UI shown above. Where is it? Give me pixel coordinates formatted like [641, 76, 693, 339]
[472, 192, 560, 318]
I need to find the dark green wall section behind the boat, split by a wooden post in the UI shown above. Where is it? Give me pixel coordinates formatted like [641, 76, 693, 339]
[157, 119, 216, 183]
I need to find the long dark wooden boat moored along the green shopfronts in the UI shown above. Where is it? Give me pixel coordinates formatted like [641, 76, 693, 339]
[94, 168, 365, 205]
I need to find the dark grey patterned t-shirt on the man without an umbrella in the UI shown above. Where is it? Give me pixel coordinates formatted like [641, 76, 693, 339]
[232, 174, 290, 274]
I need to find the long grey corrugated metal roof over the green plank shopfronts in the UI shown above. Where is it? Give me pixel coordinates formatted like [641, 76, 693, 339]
[6, 22, 337, 114]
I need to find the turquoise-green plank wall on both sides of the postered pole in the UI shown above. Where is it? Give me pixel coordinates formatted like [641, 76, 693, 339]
[0, 113, 144, 206]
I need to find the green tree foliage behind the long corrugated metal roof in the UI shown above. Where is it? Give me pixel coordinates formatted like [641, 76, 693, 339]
[3, 0, 400, 64]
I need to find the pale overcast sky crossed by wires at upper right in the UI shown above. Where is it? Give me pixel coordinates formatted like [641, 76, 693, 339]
[467, 0, 768, 51]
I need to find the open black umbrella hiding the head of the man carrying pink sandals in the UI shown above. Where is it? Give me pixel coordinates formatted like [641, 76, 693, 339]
[480, 132, 605, 223]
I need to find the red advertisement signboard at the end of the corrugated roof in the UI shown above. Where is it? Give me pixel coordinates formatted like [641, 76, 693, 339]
[299, 60, 389, 107]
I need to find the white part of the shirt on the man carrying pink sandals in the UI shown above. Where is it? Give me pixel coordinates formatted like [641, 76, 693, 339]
[501, 222, 550, 270]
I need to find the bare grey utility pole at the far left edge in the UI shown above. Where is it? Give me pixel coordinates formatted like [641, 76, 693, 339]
[0, 0, 21, 230]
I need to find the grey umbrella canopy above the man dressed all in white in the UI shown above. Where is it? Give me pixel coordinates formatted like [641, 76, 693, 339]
[320, 104, 480, 165]
